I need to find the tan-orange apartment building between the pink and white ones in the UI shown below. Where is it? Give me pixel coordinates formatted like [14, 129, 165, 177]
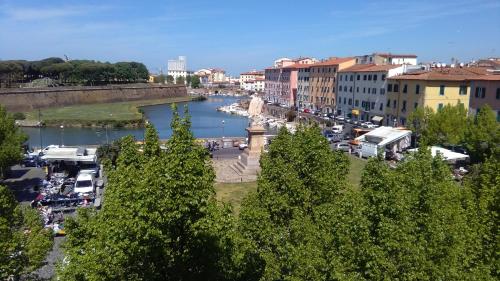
[304, 58, 356, 113]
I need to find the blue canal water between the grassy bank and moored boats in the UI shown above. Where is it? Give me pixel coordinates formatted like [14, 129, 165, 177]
[23, 96, 249, 147]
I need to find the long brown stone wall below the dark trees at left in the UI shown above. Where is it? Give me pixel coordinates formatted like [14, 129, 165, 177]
[0, 85, 187, 112]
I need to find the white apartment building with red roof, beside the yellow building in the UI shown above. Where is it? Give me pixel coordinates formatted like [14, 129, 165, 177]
[336, 64, 406, 124]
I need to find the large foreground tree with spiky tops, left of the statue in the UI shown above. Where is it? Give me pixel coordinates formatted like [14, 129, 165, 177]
[58, 104, 233, 280]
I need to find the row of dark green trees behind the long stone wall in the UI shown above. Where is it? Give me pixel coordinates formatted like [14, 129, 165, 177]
[0, 58, 149, 87]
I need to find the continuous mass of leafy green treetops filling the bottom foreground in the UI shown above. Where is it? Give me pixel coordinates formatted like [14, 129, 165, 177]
[58, 117, 500, 281]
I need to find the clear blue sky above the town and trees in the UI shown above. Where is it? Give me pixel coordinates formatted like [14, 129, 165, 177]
[0, 0, 500, 75]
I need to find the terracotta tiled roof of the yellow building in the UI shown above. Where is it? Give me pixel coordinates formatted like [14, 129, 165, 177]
[388, 67, 487, 81]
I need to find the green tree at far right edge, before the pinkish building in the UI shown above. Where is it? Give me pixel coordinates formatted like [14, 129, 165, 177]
[464, 105, 500, 163]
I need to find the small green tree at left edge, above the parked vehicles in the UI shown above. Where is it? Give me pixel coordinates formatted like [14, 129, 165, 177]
[0, 105, 27, 177]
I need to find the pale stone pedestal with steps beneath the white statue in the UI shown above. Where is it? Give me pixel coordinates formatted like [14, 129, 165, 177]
[233, 126, 266, 175]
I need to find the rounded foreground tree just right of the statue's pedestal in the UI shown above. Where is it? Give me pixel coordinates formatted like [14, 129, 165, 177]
[239, 126, 349, 280]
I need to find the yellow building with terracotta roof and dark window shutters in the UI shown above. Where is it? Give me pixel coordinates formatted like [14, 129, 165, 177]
[385, 68, 485, 126]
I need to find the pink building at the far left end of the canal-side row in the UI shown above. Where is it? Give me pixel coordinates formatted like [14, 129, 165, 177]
[264, 58, 317, 107]
